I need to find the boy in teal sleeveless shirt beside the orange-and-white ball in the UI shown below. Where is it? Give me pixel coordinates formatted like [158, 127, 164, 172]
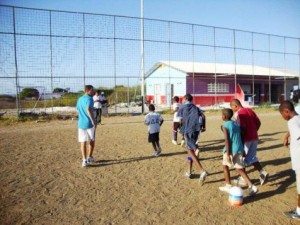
[219, 109, 258, 196]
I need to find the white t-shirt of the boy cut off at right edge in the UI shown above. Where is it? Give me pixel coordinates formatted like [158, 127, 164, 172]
[288, 115, 300, 171]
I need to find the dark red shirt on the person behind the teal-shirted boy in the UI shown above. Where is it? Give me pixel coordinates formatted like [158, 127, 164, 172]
[236, 108, 260, 142]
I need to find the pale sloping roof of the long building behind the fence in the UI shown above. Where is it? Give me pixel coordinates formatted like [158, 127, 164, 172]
[146, 61, 299, 78]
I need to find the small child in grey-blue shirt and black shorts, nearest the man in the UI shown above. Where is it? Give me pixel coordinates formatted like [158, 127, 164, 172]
[144, 104, 164, 156]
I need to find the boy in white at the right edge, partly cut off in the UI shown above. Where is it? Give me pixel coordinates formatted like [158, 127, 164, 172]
[279, 101, 300, 220]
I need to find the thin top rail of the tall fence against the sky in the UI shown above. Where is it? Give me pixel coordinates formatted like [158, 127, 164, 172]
[0, 4, 300, 41]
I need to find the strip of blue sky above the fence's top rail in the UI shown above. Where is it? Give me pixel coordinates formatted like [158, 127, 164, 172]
[0, 0, 300, 38]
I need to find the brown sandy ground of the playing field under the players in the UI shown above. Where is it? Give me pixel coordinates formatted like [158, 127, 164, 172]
[0, 112, 299, 225]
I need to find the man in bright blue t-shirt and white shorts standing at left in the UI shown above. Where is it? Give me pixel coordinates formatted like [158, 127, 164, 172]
[76, 85, 97, 167]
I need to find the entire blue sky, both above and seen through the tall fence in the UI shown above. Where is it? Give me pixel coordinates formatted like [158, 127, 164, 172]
[0, 0, 300, 93]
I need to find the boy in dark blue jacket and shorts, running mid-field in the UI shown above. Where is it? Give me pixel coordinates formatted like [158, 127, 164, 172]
[177, 94, 207, 184]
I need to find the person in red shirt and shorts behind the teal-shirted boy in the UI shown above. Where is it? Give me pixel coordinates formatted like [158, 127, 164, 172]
[230, 99, 268, 185]
